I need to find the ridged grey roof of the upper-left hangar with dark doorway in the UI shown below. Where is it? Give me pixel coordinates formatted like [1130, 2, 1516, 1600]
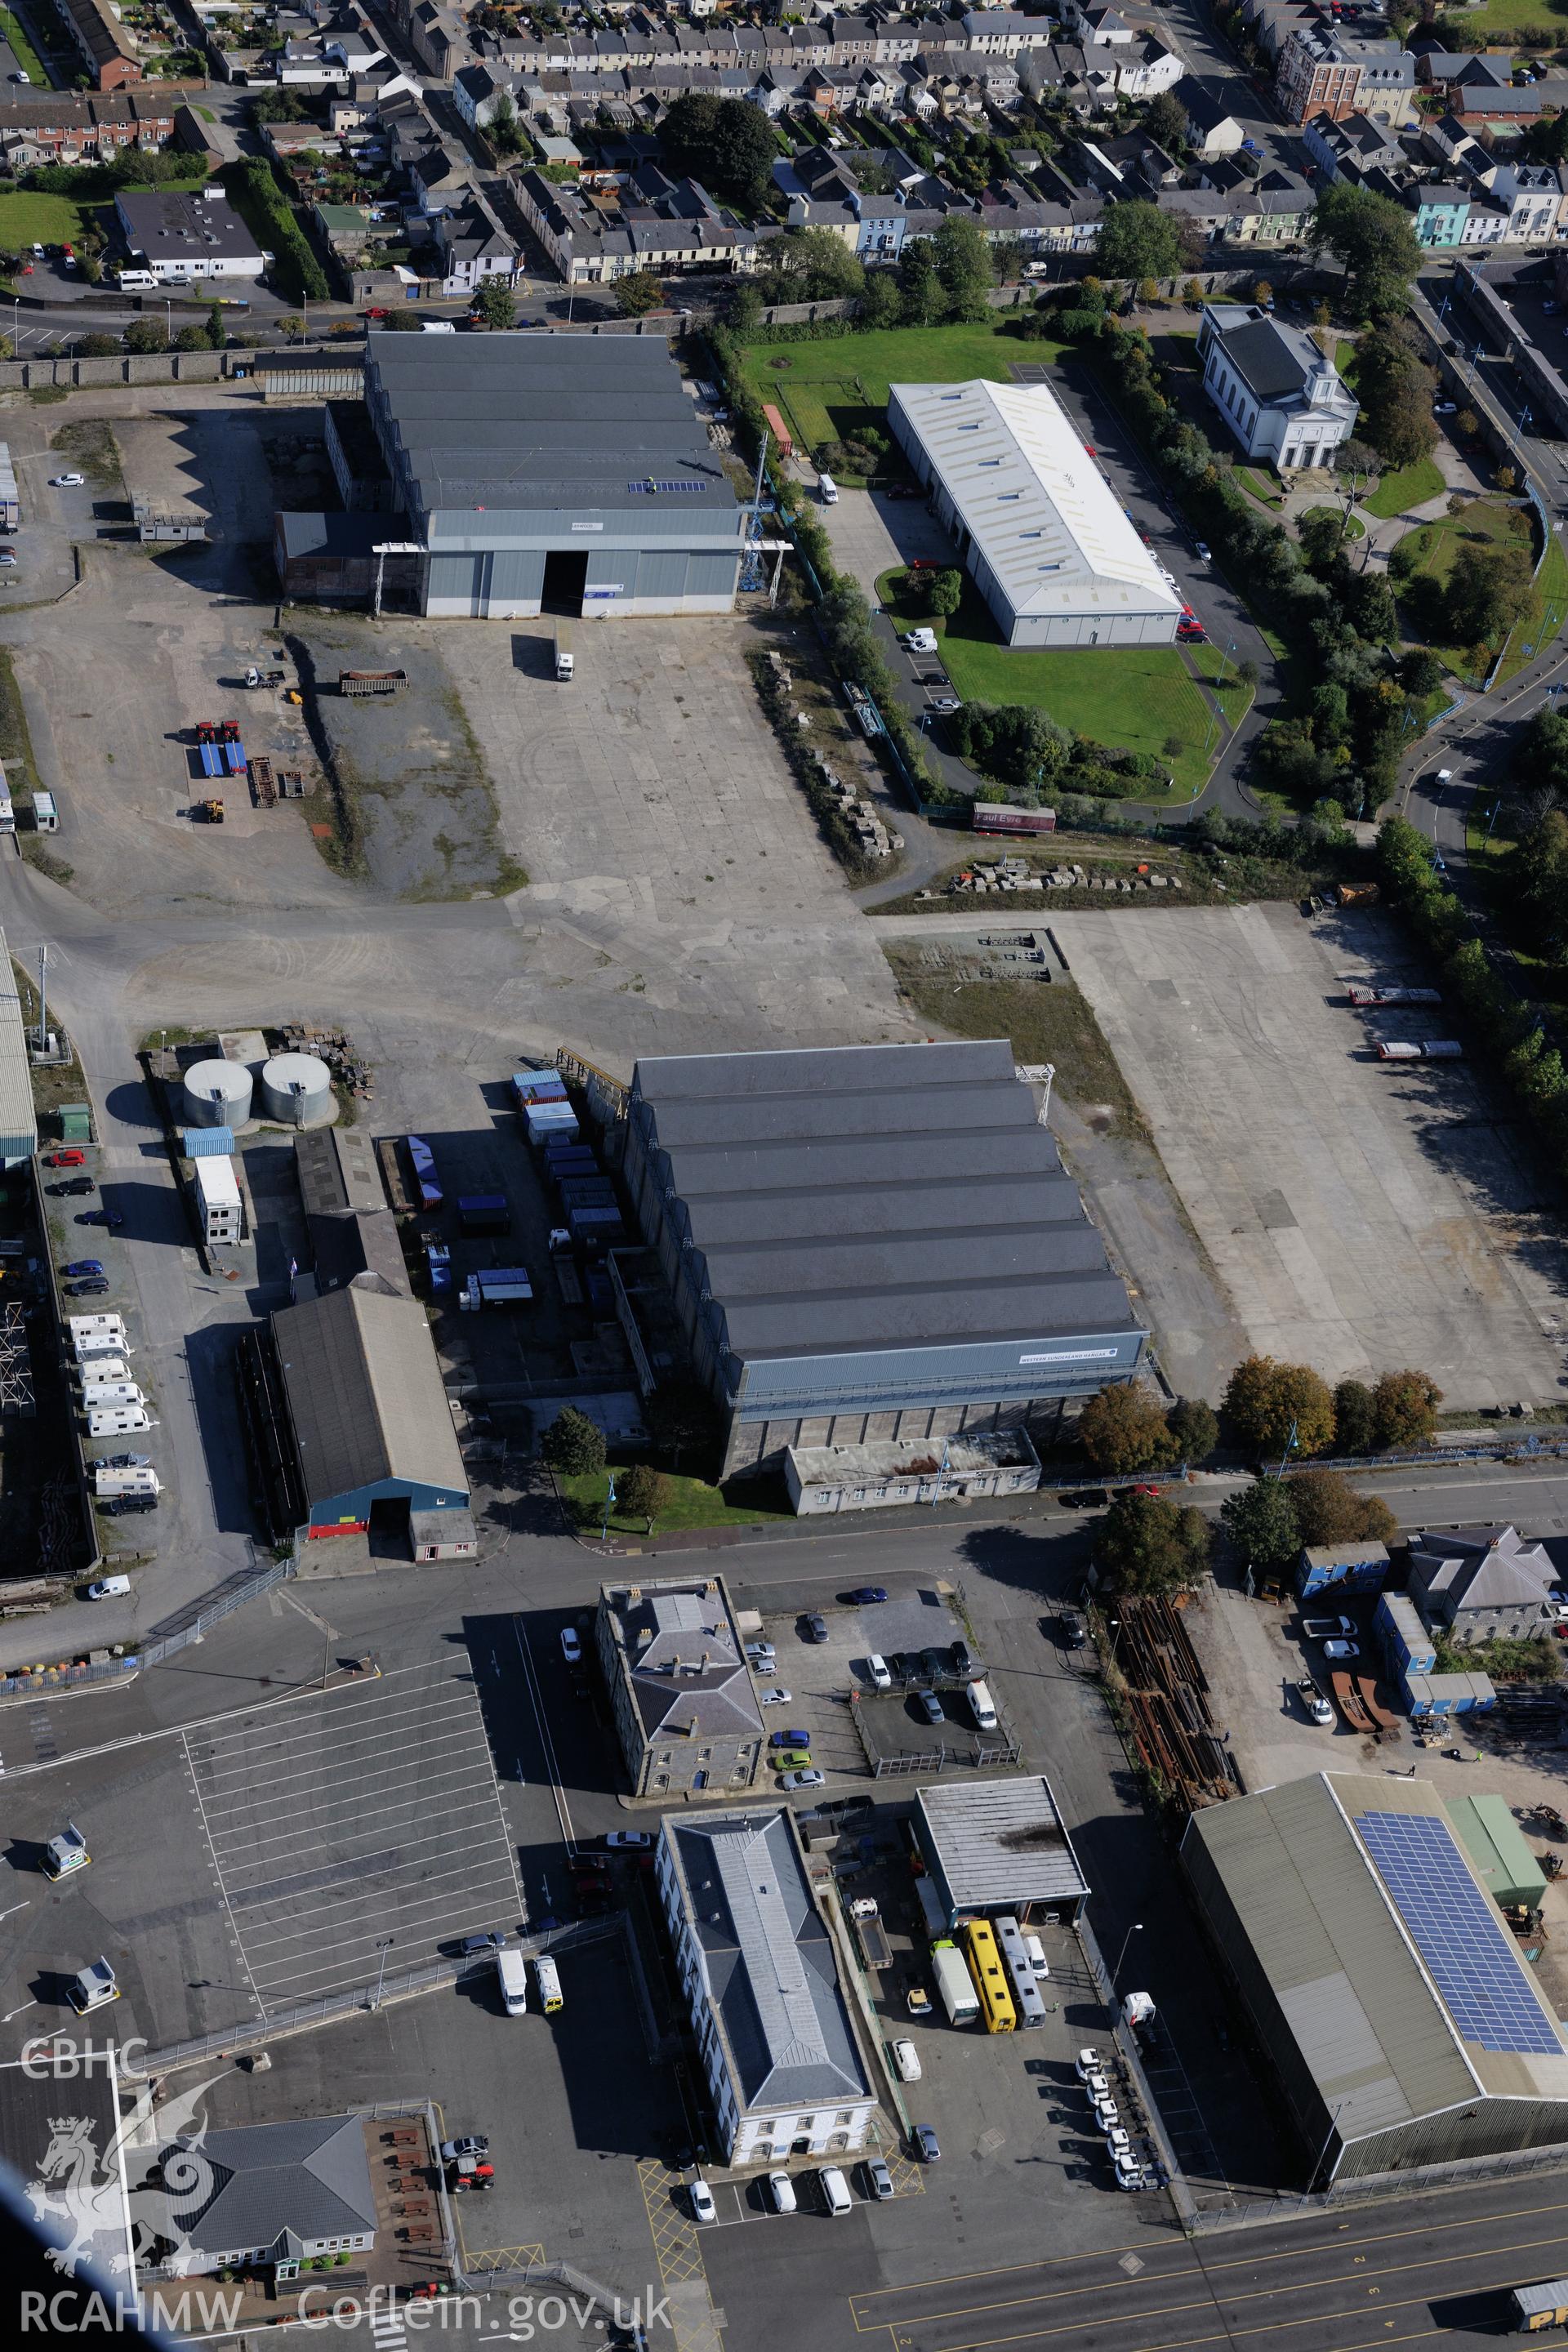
[367, 332, 738, 519]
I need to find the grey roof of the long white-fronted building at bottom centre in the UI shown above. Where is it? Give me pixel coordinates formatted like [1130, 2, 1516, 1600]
[666, 1809, 870, 2114]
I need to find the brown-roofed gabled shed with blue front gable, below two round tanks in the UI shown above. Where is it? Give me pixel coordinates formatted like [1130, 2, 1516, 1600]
[273, 1275, 468, 1536]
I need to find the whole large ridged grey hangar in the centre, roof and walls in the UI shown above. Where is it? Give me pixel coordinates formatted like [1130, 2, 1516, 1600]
[626, 1040, 1147, 1475]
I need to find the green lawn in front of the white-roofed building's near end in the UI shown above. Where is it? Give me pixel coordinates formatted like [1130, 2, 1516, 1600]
[877, 572, 1241, 807]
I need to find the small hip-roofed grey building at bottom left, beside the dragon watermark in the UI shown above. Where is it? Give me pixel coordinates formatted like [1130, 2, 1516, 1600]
[158, 2114, 376, 2279]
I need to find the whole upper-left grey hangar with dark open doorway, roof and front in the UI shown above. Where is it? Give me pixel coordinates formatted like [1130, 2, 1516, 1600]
[364, 332, 746, 621]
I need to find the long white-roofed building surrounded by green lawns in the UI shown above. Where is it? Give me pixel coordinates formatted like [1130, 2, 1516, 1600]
[889, 379, 1183, 644]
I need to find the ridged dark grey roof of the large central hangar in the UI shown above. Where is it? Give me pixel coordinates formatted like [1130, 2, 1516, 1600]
[632, 1040, 1140, 1360]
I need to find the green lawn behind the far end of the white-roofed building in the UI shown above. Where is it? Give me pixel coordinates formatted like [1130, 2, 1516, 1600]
[743, 320, 1062, 463]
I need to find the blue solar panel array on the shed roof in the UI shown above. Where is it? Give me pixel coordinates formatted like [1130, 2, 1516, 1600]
[1356, 1813, 1563, 2058]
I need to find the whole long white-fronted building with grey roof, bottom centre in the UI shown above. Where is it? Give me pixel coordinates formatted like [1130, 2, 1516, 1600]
[656, 1806, 877, 2164]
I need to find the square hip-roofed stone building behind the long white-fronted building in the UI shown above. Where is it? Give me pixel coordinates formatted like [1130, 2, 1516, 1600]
[597, 1576, 766, 1797]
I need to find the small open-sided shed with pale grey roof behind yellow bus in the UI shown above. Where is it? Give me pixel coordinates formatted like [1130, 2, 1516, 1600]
[915, 1778, 1089, 1927]
